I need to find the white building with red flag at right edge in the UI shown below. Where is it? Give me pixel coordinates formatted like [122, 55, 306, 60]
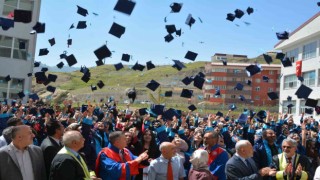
[274, 13, 320, 119]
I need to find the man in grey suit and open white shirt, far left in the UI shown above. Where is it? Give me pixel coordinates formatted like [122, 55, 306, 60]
[0, 125, 46, 180]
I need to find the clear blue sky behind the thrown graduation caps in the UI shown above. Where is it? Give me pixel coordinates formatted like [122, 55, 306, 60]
[35, 0, 320, 67]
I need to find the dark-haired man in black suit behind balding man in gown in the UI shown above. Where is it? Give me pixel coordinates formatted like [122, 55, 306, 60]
[41, 120, 64, 176]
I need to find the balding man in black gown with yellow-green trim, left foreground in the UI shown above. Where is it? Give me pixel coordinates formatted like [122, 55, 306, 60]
[49, 131, 99, 180]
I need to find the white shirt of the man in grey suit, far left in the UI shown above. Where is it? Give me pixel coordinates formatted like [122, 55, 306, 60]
[10, 143, 34, 180]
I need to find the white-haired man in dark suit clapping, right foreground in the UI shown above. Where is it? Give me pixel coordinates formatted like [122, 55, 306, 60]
[225, 140, 276, 180]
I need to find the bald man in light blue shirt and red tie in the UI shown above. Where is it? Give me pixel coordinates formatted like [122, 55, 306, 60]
[148, 142, 186, 180]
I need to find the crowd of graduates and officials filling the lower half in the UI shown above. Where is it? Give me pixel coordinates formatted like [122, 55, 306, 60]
[0, 99, 320, 180]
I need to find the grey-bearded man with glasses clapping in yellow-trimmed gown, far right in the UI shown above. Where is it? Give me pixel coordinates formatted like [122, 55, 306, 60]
[272, 138, 313, 180]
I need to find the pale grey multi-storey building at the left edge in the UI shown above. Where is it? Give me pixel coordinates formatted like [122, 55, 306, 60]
[0, 0, 41, 100]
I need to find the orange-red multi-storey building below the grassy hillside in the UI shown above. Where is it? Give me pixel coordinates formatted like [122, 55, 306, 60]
[204, 62, 280, 106]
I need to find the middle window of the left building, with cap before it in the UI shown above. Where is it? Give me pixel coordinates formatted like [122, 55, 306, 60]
[0, 35, 28, 60]
